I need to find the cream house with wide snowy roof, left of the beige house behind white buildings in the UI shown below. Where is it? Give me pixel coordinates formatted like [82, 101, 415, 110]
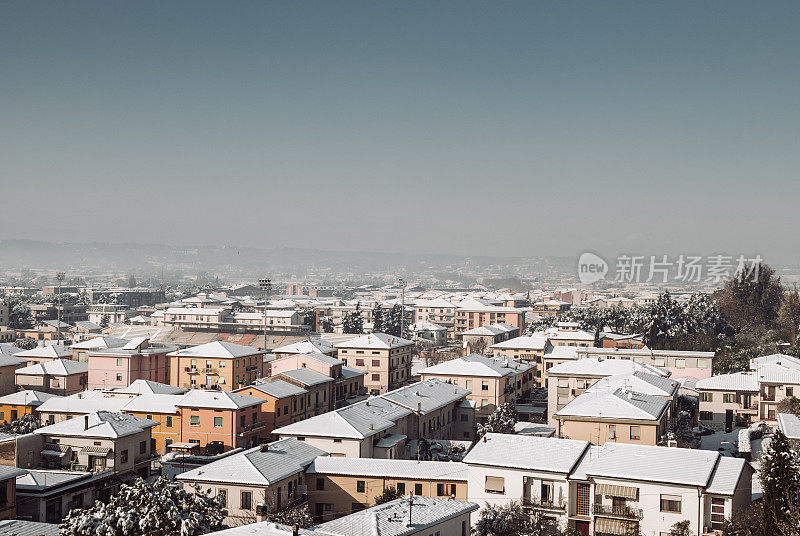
[419, 354, 536, 426]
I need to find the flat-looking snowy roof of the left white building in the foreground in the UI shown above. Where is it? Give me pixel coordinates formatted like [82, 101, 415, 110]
[464, 433, 589, 474]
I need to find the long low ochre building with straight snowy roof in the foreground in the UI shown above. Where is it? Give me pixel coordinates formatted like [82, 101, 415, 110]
[306, 456, 467, 522]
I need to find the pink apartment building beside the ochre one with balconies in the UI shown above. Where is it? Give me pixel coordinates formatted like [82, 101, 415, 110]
[86, 337, 177, 389]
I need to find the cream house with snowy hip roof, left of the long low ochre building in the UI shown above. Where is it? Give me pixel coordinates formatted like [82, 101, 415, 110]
[175, 439, 327, 525]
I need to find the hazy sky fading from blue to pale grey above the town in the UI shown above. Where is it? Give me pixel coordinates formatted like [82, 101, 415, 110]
[0, 0, 800, 260]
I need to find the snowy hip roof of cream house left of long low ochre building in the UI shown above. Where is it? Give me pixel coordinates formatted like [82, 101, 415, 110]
[175, 438, 328, 486]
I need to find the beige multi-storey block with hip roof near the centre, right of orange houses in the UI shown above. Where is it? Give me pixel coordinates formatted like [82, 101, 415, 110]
[336, 333, 414, 395]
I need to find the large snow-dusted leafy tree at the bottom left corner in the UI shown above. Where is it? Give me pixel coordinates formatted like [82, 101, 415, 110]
[59, 477, 227, 536]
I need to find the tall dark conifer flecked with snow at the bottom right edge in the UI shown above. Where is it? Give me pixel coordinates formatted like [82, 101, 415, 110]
[758, 429, 800, 534]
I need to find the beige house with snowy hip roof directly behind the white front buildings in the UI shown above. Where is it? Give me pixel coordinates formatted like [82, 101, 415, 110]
[553, 388, 670, 445]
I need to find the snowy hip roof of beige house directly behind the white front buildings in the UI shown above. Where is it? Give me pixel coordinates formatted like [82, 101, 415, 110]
[555, 389, 670, 421]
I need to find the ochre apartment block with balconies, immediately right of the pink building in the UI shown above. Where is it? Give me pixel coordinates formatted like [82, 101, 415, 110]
[167, 341, 269, 391]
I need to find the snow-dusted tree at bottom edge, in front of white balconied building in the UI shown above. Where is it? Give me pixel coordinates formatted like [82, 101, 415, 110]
[472, 502, 561, 536]
